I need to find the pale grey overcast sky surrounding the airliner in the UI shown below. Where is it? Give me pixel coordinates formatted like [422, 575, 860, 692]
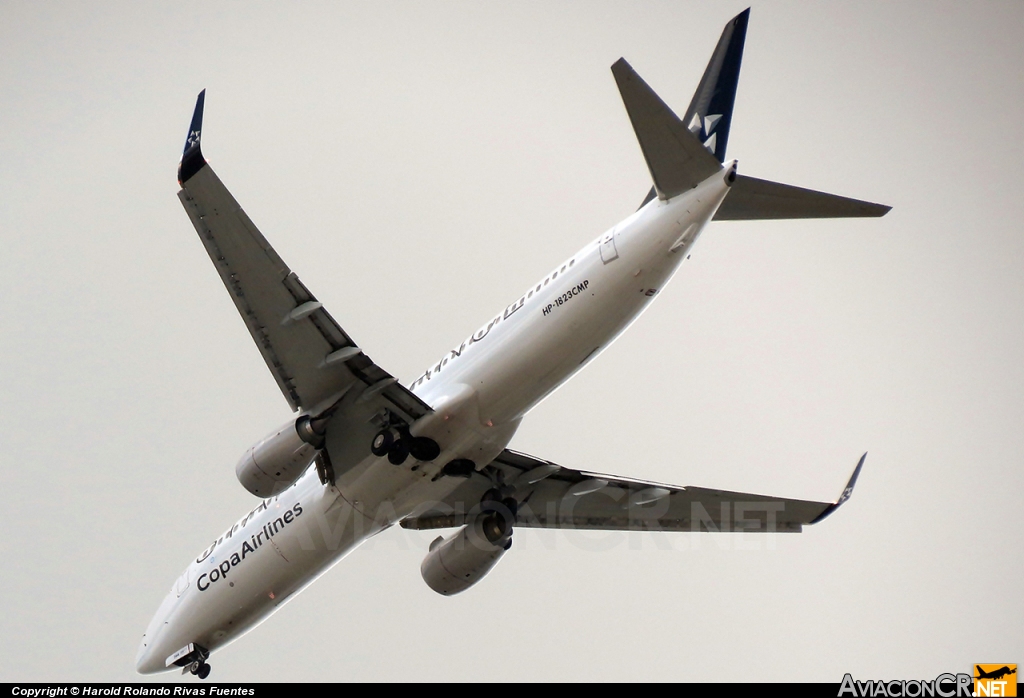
[0, 1, 1024, 682]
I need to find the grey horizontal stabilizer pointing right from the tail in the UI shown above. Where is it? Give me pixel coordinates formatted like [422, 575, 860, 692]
[714, 175, 892, 220]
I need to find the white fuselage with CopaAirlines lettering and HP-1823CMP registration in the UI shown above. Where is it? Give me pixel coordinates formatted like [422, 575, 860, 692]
[136, 163, 731, 673]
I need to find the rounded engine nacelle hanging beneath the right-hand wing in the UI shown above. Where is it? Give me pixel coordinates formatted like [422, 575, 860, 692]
[420, 512, 512, 597]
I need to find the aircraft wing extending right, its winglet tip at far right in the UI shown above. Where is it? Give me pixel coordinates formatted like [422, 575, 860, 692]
[401, 449, 867, 533]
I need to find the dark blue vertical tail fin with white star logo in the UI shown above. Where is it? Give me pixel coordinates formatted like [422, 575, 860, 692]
[683, 7, 751, 163]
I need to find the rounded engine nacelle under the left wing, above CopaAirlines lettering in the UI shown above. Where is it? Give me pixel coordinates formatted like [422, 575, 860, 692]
[234, 417, 324, 497]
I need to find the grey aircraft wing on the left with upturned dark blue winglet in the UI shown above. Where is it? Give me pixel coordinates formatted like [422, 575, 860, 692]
[178, 90, 431, 422]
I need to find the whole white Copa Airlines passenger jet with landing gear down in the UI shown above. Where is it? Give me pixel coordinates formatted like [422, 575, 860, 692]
[136, 9, 890, 679]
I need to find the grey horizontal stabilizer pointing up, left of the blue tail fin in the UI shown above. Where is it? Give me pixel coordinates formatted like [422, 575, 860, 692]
[611, 58, 722, 200]
